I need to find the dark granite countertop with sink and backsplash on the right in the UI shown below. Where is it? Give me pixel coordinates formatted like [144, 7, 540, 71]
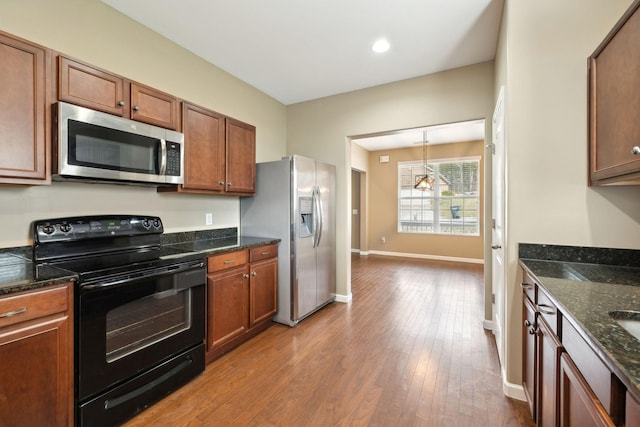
[520, 245, 640, 399]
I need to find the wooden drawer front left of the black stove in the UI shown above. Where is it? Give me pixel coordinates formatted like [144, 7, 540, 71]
[0, 286, 67, 328]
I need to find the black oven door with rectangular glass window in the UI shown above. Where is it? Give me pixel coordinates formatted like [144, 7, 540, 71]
[76, 261, 206, 402]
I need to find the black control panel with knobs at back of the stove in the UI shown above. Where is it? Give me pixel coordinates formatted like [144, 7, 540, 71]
[34, 215, 163, 243]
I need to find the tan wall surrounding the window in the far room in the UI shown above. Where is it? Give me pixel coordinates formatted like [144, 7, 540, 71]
[367, 141, 484, 262]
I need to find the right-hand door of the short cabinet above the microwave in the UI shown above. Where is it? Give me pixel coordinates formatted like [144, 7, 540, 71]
[131, 83, 178, 130]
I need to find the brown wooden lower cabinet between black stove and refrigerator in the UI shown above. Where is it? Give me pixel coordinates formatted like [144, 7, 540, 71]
[206, 245, 278, 362]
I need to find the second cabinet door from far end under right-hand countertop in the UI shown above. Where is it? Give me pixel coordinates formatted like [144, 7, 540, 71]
[536, 317, 562, 427]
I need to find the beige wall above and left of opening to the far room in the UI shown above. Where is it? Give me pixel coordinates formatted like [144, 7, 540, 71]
[287, 61, 493, 297]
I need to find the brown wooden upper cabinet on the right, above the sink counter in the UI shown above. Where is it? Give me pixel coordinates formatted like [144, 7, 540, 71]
[588, 0, 640, 185]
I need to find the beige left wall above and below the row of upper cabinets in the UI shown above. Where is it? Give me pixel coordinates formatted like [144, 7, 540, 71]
[0, 0, 287, 247]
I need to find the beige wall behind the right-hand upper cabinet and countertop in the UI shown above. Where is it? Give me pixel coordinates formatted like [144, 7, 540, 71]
[495, 0, 640, 392]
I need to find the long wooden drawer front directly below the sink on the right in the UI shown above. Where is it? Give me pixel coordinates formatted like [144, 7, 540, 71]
[562, 319, 624, 420]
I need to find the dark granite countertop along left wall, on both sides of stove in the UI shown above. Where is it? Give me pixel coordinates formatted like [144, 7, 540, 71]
[0, 228, 280, 296]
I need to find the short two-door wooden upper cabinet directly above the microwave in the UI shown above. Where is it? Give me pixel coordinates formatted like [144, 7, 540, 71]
[58, 55, 179, 130]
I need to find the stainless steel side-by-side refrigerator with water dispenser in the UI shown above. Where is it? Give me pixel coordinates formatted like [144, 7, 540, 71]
[240, 156, 336, 326]
